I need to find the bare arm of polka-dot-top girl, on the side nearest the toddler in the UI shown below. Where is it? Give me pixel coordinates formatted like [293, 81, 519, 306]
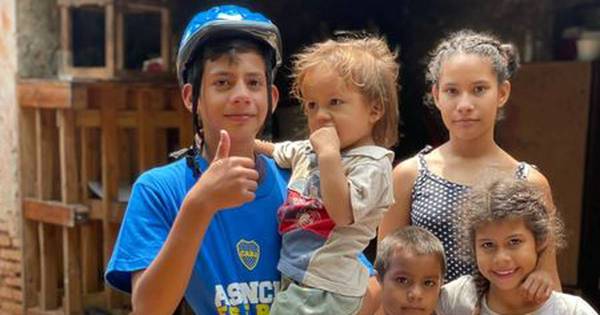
[377, 157, 417, 241]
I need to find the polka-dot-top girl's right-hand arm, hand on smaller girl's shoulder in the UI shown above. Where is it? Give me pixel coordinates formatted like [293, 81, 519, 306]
[521, 170, 562, 301]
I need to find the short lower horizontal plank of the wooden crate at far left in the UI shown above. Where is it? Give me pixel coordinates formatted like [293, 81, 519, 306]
[23, 198, 89, 227]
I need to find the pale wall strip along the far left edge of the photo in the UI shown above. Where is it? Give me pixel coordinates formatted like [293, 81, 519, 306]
[0, 0, 23, 314]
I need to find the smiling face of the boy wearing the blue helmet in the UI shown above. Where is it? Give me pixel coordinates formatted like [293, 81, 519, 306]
[184, 52, 278, 153]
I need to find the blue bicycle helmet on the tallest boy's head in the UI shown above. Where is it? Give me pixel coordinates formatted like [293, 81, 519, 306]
[177, 5, 281, 85]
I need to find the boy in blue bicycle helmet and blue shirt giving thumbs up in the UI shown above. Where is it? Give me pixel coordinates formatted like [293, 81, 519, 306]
[106, 6, 288, 314]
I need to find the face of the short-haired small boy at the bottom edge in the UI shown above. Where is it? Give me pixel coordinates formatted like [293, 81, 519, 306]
[380, 250, 443, 315]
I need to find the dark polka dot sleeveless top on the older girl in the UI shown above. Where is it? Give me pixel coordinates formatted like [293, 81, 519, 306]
[410, 146, 530, 282]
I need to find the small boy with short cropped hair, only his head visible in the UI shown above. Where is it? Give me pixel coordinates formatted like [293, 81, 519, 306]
[375, 226, 446, 315]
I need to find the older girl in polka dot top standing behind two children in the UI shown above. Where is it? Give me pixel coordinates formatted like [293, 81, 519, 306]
[379, 30, 560, 300]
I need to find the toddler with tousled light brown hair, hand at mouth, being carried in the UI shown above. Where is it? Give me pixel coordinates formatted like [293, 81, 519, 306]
[257, 36, 398, 315]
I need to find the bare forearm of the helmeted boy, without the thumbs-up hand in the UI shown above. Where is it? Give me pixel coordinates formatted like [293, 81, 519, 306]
[131, 201, 214, 314]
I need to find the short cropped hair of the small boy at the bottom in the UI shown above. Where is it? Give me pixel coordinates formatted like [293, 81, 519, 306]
[374, 226, 446, 279]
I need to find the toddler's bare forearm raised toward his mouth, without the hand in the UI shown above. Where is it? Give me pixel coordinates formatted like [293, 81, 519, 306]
[319, 152, 354, 225]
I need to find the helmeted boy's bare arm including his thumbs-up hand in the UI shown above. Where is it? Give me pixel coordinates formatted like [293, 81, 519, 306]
[131, 131, 258, 315]
